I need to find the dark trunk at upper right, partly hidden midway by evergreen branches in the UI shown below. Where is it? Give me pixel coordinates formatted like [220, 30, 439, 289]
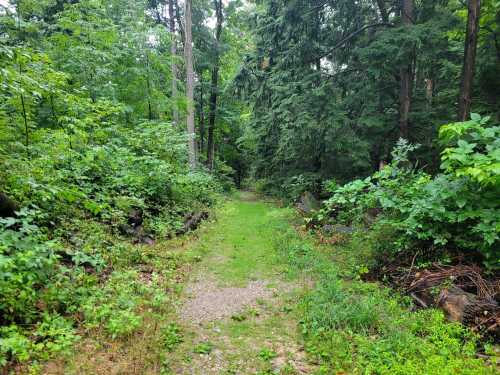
[399, 0, 415, 139]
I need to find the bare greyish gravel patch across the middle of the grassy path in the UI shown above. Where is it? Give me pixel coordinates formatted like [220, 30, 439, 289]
[181, 280, 277, 324]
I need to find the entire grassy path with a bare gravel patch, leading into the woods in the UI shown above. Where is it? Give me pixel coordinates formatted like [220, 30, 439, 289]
[169, 193, 311, 374]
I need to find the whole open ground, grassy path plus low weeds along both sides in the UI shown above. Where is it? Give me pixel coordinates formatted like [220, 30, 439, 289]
[40, 192, 498, 375]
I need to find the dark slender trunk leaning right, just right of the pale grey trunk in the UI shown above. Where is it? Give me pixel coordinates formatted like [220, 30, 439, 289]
[207, 0, 224, 169]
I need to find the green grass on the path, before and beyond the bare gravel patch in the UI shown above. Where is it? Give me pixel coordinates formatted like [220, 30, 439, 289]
[160, 193, 308, 374]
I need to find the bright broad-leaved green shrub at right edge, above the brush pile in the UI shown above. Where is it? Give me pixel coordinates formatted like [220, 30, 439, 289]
[321, 115, 500, 268]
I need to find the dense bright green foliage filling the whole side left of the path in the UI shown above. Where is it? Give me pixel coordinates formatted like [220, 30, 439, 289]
[0, 1, 221, 366]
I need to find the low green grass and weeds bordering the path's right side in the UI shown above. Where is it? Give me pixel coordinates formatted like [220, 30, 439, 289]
[275, 228, 495, 375]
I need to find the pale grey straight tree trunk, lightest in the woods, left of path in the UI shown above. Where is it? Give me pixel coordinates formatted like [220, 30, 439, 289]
[184, 0, 196, 169]
